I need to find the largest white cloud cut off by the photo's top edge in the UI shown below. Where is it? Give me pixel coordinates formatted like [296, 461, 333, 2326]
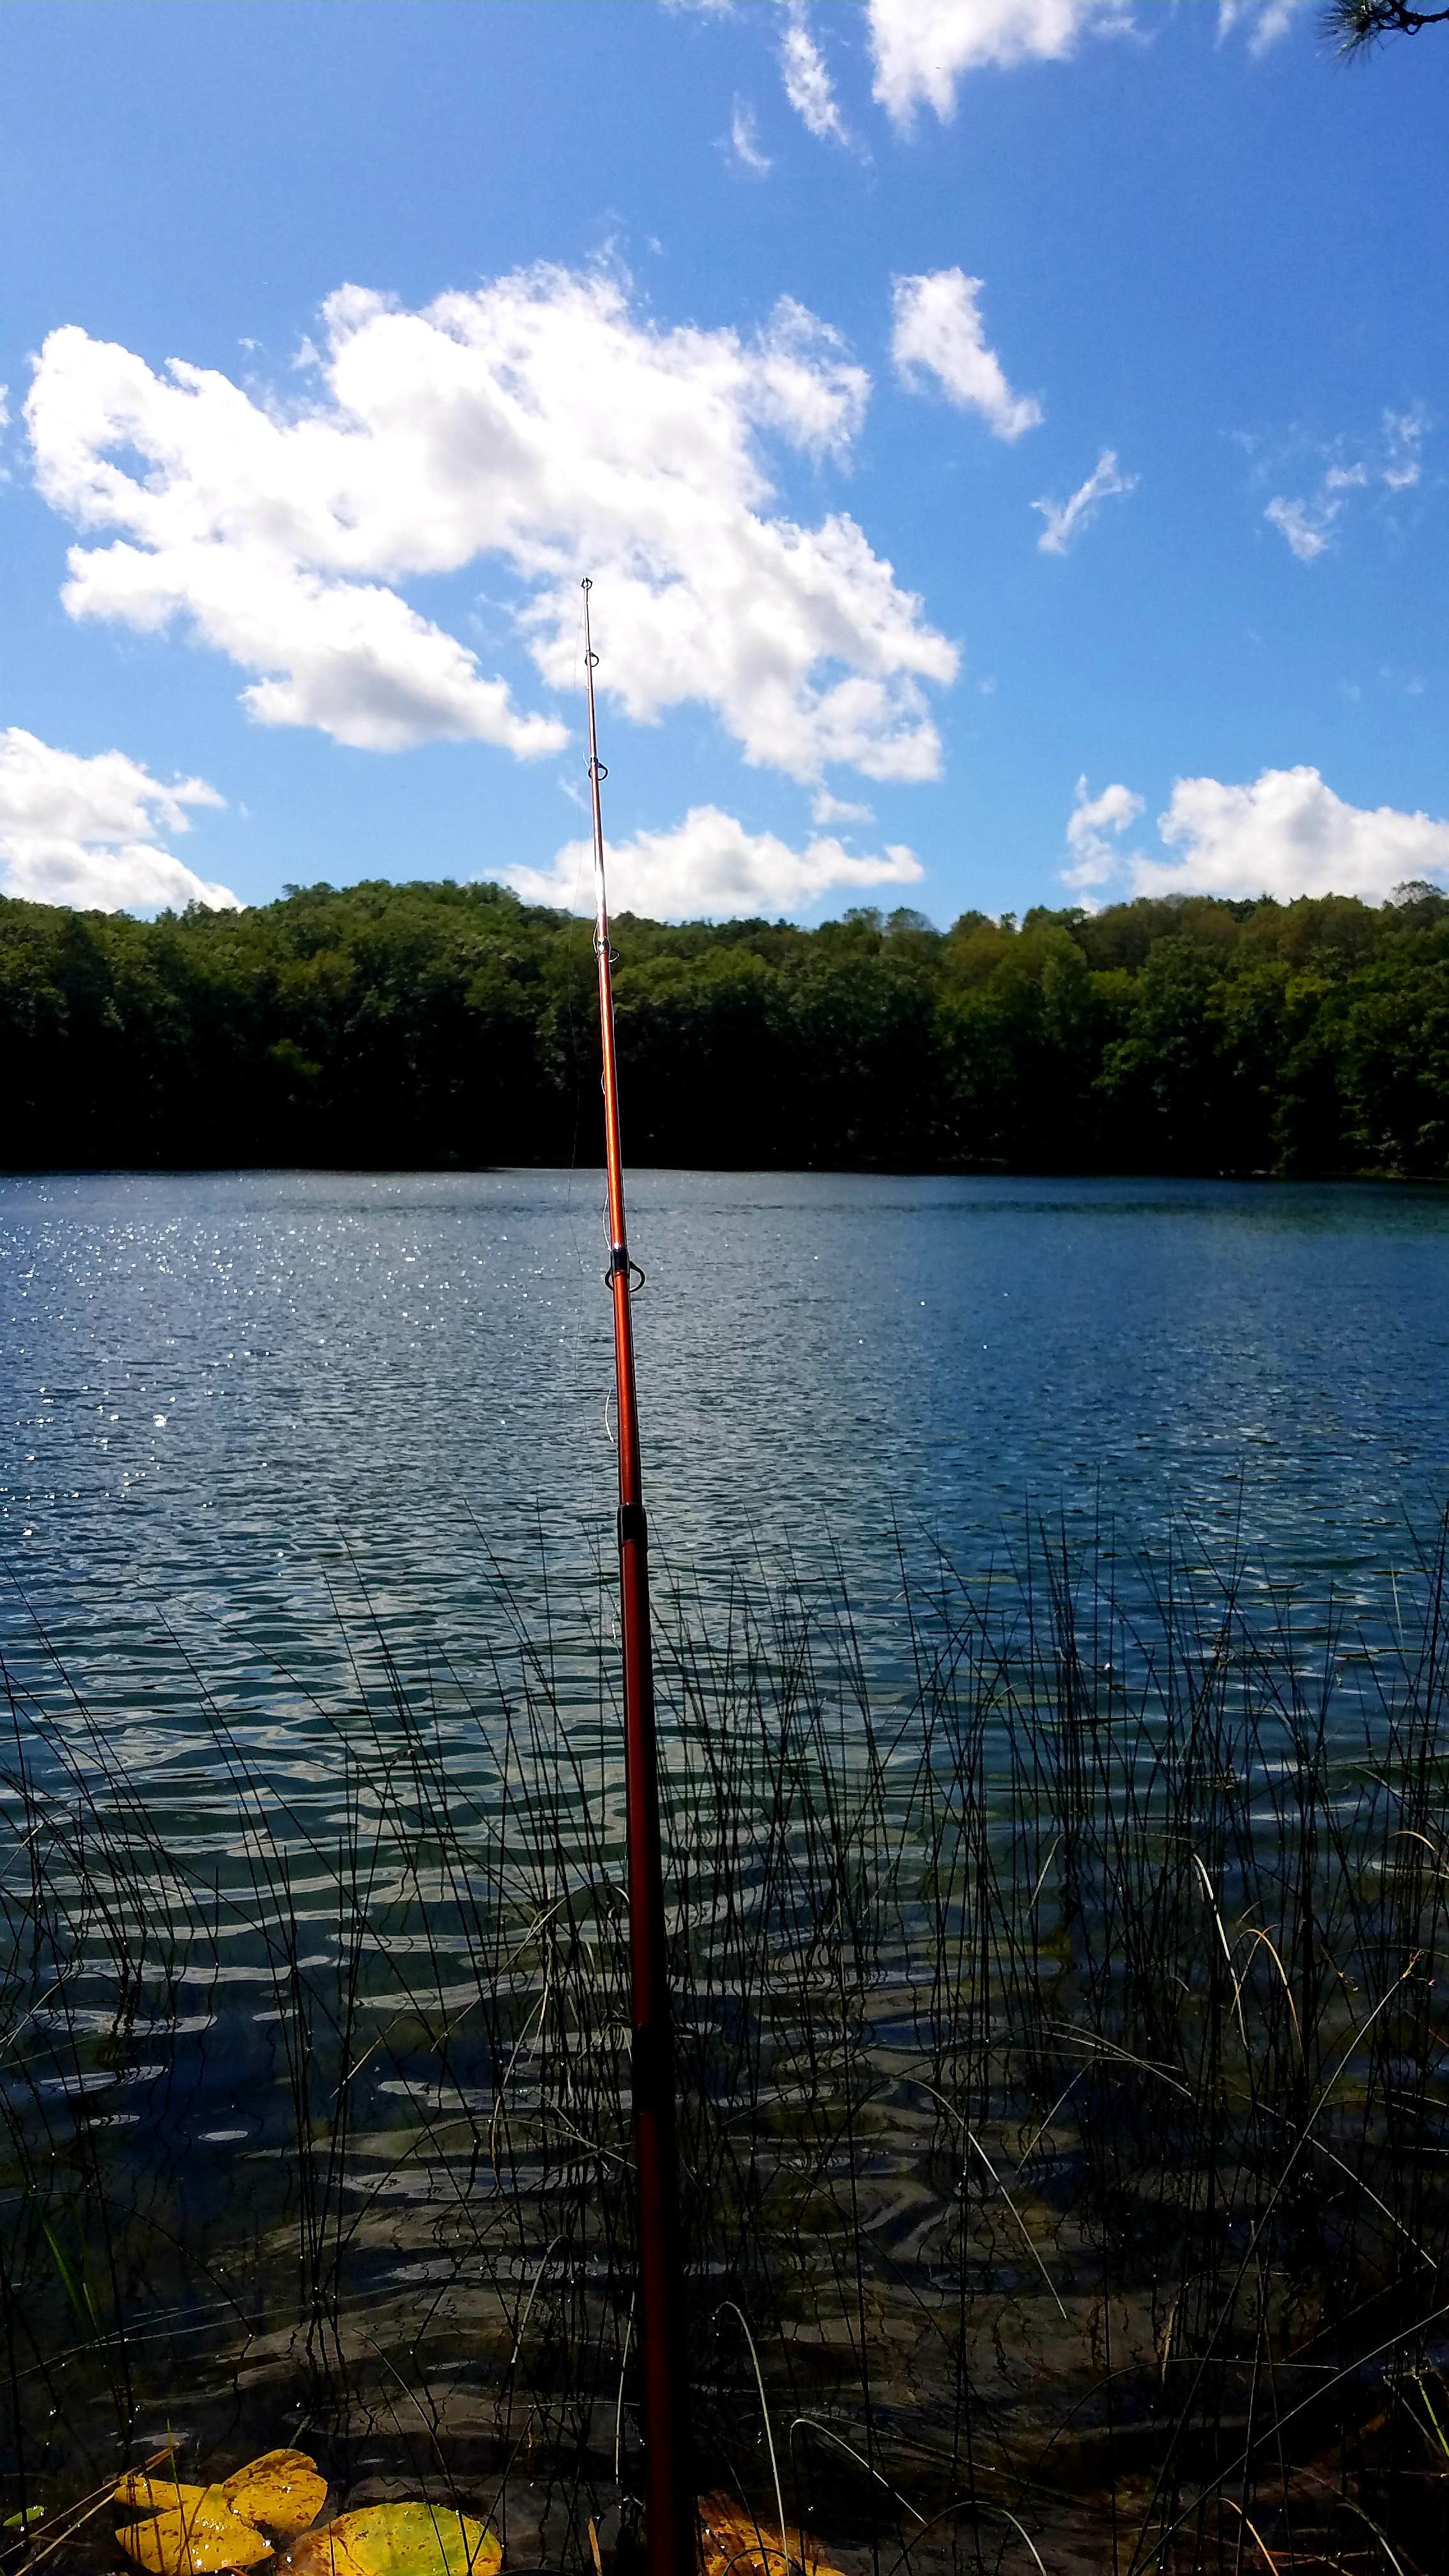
[869, 0, 1132, 126]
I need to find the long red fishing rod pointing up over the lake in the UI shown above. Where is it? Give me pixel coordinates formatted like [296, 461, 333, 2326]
[583, 579, 699, 2576]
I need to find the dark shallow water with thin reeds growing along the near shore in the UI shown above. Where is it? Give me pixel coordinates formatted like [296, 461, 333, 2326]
[0, 1538, 1449, 2576]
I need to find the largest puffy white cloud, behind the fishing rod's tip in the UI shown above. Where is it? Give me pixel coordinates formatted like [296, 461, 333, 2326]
[28, 268, 956, 778]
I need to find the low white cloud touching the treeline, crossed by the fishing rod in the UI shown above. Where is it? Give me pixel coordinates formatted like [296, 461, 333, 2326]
[505, 806, 926, 919]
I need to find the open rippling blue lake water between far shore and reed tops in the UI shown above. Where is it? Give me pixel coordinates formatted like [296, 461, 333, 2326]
[0, 1172, 1449, 1757]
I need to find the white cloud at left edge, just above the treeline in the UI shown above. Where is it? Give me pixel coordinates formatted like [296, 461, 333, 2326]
[0, 724, 240, 912]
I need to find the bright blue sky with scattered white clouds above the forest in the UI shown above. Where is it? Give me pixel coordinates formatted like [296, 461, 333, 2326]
[0, 0, 1449, 922]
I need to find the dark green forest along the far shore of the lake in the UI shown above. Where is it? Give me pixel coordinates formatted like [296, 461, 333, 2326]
[0, 881, 1449, 1177]
